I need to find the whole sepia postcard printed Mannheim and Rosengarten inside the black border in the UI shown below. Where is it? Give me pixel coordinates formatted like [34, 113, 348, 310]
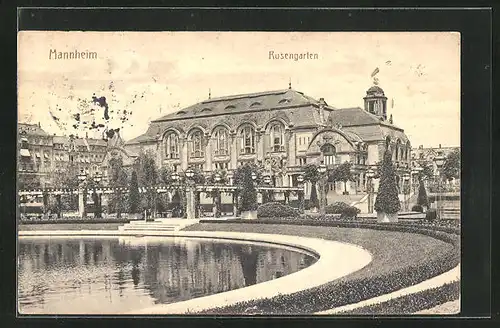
[17, 31, 461, 316]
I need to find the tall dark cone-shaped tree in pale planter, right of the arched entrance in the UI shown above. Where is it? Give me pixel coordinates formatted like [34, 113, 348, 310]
[374, 150, 401, 214]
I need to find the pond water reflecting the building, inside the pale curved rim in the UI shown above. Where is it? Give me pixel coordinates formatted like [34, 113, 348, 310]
[18, 238, 315, 314]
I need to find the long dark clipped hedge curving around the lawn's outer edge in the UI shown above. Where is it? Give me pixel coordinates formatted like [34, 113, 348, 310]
[193, 221, 460, 315]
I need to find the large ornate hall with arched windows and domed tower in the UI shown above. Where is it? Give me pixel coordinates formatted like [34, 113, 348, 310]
[123, 85, 411, 192]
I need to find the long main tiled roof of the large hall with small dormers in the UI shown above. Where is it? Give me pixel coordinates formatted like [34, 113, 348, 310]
[153, 89, 318, 122]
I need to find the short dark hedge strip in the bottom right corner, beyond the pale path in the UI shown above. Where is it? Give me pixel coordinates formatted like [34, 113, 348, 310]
[339, 281, 460, 315]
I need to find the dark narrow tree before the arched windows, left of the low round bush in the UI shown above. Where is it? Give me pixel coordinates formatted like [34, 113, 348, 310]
[234, 164, 258, 212]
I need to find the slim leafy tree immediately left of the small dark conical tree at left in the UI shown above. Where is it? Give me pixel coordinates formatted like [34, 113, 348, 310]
[108, 157, 128, 218]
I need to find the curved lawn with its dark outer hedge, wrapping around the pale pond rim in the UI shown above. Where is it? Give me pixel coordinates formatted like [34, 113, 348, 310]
[185, 220, 460, 315]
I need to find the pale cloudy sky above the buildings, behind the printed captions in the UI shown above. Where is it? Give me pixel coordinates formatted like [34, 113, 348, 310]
[18, 31, 460, 147]
